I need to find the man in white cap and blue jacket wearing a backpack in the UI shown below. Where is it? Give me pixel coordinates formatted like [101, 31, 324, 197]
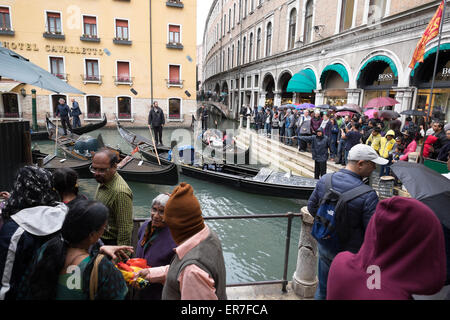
[308, 144, 388, 300]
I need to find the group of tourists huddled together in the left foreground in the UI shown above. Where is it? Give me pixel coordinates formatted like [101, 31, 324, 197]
[0, 149, 226, 300]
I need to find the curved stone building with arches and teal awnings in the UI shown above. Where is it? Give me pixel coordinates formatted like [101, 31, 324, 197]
[202, 0, 450, 121]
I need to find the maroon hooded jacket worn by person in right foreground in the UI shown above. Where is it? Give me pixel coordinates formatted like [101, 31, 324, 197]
[327, 197, 446, 300]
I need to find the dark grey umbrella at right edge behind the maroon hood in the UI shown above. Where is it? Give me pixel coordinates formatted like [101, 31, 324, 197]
[391, 161, 450, 228]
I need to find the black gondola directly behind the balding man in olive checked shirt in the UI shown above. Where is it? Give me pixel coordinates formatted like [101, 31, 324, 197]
[47, 118, 179, 185]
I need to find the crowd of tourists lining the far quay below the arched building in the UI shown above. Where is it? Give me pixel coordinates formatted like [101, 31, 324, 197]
[242, 107, 450, 179]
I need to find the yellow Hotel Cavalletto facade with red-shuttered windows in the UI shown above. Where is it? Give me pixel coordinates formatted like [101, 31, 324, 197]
[0, 0, 197, 125]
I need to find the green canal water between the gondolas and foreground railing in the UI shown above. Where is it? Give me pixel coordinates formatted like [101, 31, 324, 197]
[33, 121, 306, 283]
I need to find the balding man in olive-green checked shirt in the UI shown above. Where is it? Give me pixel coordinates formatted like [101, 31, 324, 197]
[91, 149, 133, 246]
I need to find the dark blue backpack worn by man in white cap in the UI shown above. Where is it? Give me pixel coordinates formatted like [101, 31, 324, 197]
[311, 173, 373, 251]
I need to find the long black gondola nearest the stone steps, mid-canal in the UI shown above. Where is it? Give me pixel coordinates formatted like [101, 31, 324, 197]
[117, 125, 317, 200]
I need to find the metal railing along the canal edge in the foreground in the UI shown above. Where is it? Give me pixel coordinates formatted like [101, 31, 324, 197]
[133, 212, 302, 292]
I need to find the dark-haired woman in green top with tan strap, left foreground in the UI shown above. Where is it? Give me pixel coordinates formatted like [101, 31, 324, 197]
[18, 200, 128, 300]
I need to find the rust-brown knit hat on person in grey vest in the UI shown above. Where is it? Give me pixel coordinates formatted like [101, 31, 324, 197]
[164, 182, 205, 244]
